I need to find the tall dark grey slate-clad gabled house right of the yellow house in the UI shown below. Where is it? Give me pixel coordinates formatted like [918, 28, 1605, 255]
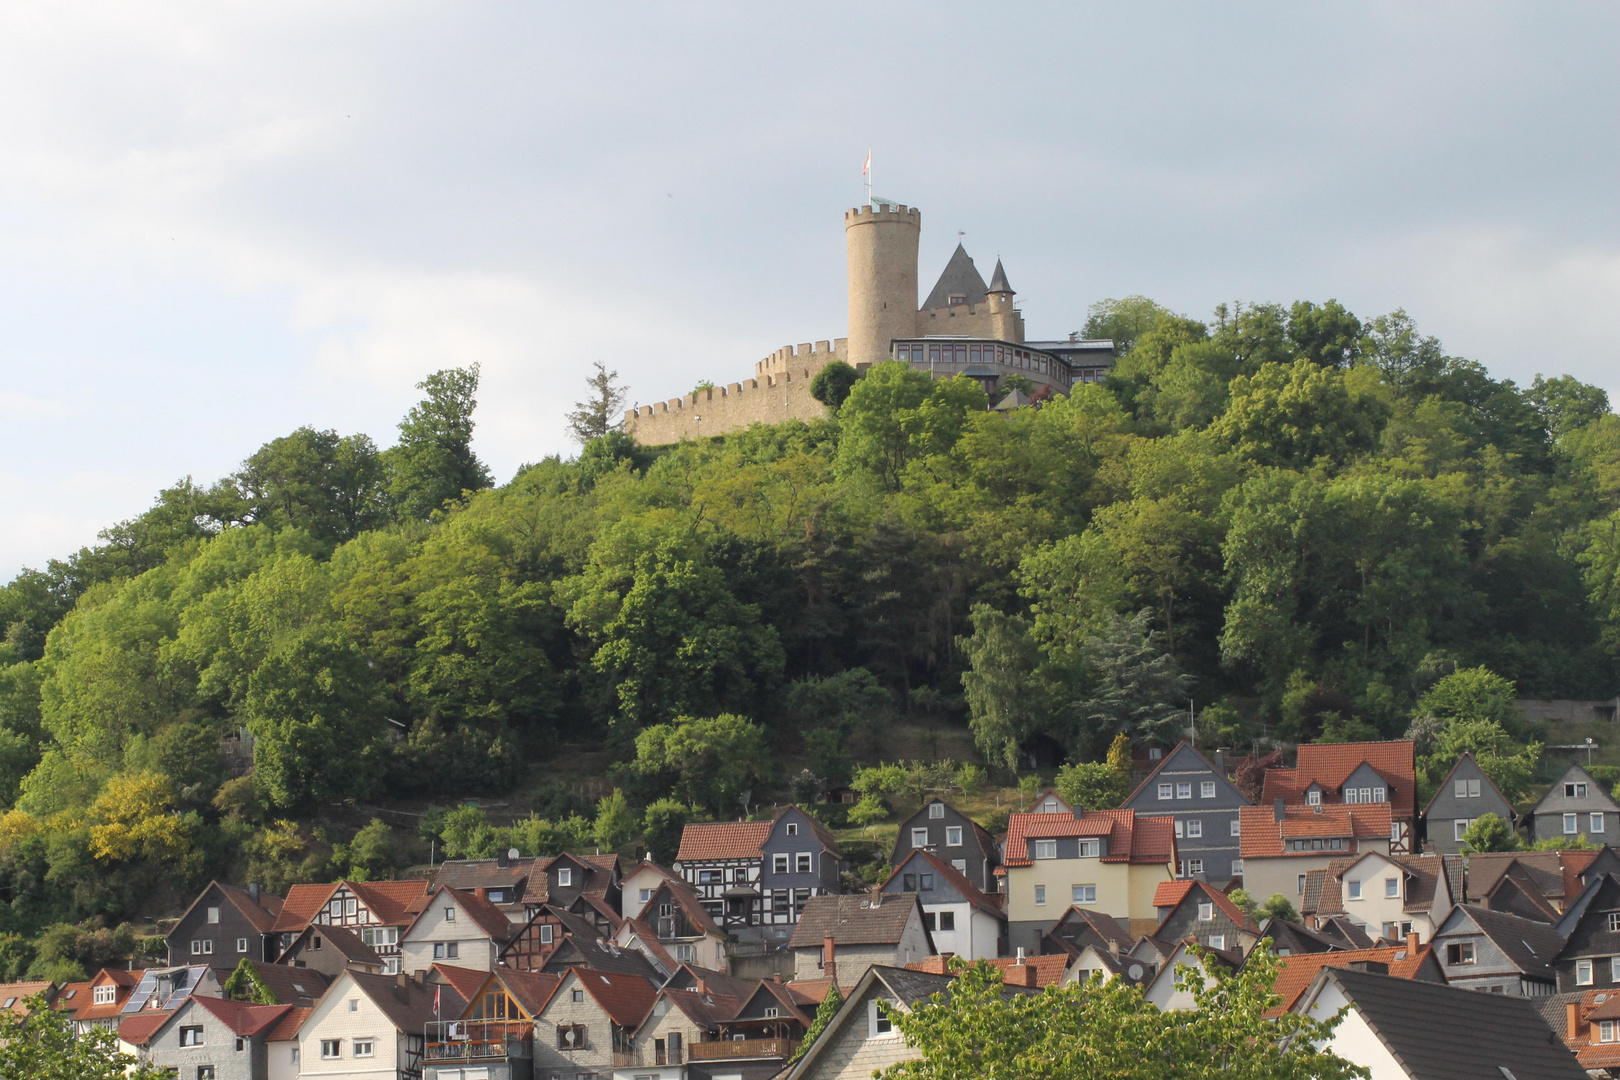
[1119, 742, 1251, 882]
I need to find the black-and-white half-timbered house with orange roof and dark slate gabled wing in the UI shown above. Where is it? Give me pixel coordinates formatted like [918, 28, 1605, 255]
[674, 806, 842, 941]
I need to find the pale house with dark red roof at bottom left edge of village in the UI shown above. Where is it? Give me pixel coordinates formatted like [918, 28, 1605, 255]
[120, 997, 292, 1080]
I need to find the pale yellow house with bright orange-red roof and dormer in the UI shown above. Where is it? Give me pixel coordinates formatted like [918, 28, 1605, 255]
[996, 810, 1176, 954]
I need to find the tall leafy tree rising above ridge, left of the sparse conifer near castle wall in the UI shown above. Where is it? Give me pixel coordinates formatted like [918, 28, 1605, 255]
[384, 364, 491, 521]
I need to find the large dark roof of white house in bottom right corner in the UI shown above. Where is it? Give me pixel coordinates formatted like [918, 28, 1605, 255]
[1324, 971, 1586, 1080]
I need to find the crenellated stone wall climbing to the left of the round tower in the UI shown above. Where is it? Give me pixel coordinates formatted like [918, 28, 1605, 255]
[624, 338, 844, 447]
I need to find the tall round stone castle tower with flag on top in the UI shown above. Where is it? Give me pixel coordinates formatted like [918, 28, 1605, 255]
[844, 202, 922, 366]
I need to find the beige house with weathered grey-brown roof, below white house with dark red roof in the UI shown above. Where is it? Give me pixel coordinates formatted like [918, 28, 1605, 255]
[787, 892, 935, 988]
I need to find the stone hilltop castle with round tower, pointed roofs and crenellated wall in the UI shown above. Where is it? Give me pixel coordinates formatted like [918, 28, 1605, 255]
[624, 199, 1113, 445]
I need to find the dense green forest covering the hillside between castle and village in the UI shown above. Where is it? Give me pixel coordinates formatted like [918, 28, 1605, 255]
[0, 298, 1620, 978]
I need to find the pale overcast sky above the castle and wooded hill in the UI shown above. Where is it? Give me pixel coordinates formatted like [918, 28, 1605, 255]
[0, 0, 1620, 576]
